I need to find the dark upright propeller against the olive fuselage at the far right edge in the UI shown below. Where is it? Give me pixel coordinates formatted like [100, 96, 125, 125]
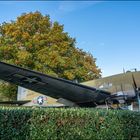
[132, 74, 140, 111]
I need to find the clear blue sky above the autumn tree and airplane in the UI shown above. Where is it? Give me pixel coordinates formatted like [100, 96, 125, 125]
[0, 0, 140, 77]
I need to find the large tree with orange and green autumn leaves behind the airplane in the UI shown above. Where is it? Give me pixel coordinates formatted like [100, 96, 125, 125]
[0, 12, 101, 100]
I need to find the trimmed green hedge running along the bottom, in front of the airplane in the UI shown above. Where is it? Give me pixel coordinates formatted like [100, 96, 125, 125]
[0, 107, 140, 140]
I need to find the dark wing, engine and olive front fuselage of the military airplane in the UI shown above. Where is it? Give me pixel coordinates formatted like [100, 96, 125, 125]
[0, 62, 140, 109]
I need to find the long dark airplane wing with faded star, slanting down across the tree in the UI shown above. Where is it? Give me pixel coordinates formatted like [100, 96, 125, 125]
[0, 62, 110, 107]
